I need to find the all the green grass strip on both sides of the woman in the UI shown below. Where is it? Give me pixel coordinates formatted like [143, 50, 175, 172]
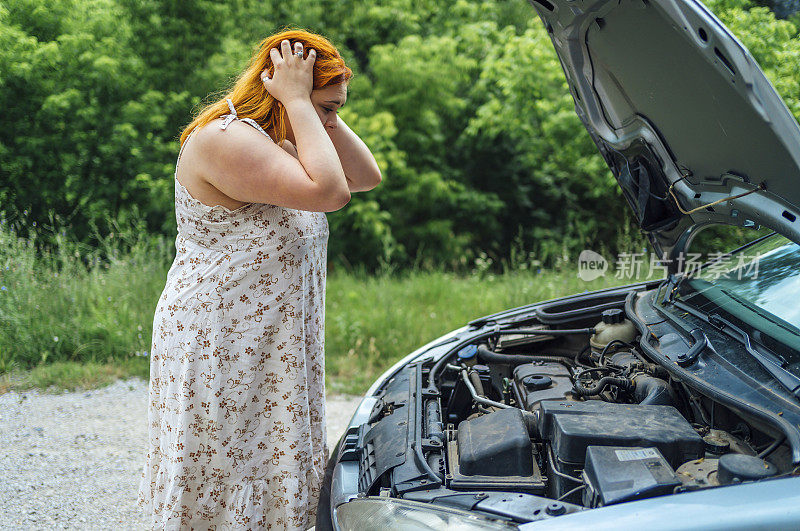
[0, 220, 632, 394]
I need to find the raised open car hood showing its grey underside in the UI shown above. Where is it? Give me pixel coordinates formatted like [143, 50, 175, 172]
[530, 0, 800, 263]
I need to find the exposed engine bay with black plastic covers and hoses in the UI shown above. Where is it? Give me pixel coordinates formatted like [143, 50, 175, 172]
[348, 295, 792, 523]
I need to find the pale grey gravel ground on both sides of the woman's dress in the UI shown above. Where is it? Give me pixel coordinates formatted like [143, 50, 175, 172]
[0, 378, 360, 530]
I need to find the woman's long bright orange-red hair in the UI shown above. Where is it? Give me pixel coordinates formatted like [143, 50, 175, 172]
[186, 30, 353, 145]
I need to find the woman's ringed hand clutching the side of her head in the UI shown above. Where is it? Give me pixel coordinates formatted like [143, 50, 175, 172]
[261, 39, 317, 106]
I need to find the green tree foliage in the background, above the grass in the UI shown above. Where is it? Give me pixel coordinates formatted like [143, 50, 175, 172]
[0, 0, 800, 269]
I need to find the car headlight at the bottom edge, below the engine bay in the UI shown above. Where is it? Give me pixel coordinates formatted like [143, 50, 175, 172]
[334, 498, 519, 531]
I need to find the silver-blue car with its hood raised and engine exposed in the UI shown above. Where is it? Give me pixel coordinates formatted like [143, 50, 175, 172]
[317, 0, 800, 531]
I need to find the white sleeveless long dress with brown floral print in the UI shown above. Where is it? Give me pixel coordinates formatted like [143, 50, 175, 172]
[138, 104, 328, 530]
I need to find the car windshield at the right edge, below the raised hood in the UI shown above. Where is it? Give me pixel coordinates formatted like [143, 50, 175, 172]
[676, 234, 800, 374]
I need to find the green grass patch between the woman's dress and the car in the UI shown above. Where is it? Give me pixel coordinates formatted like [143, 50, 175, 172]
[325, 271, 620, 393]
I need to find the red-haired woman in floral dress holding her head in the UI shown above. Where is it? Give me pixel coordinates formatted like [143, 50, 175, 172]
[139, 31, 381, 529]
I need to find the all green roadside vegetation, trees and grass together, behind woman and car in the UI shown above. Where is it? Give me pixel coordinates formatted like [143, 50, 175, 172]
[0, 0, 800, 393]
